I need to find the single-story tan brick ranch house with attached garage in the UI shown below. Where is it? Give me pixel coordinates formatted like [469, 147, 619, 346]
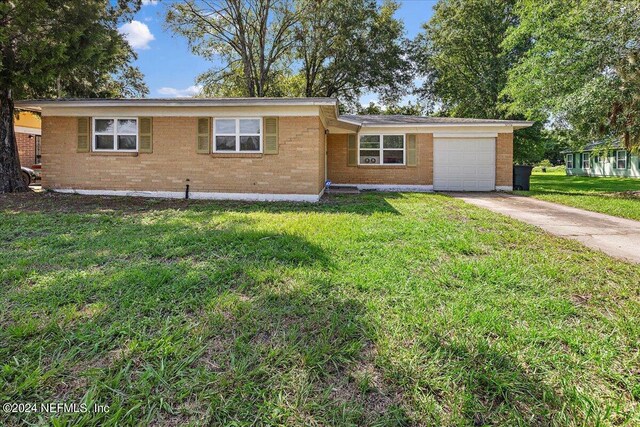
[17, 98, 532, 201]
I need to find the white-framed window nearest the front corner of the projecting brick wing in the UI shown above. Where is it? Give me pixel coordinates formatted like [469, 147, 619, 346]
[213, 119, 262, 153]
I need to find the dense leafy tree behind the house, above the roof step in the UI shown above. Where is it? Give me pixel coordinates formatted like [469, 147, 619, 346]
[295, 0, 411, 103]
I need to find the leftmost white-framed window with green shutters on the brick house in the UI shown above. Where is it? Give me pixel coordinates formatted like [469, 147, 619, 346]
[93, 117, 138, 151]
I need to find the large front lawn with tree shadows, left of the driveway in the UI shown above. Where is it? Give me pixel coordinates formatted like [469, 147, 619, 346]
[0, 193, 640, 426]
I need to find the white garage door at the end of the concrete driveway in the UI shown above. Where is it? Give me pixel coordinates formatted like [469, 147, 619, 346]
[433, 138, 496, 191]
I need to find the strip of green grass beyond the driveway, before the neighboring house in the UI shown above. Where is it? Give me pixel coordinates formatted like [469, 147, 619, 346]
[516, 167, 640, 220]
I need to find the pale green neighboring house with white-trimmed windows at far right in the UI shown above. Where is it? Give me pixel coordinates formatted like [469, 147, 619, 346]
[563, 142, 640, 178]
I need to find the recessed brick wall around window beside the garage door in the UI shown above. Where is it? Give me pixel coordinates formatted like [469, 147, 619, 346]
[327, 134, 433, 185]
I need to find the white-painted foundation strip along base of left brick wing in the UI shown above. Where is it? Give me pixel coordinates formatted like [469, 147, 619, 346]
[51, 188, 324, 203]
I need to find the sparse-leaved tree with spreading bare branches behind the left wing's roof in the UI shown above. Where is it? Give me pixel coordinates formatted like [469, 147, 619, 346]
[166, 0, 299, 97]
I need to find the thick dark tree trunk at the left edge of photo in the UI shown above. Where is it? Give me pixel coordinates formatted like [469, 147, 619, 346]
[0, 89, 27, 193]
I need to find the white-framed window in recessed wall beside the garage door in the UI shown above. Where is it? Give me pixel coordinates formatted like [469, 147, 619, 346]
[358, 135, 405, 165]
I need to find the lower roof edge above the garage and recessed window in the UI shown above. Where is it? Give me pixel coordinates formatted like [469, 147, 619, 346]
[338, 114, 533, 126]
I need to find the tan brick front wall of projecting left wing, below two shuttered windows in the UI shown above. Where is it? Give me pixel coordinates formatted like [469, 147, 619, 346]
[42, 117, 324, 194]
